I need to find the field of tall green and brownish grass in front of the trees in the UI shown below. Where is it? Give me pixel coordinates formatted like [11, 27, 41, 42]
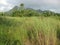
[0, 17, 60, 45]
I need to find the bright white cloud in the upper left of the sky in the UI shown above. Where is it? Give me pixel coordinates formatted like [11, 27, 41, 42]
[0, 0, 13, 11]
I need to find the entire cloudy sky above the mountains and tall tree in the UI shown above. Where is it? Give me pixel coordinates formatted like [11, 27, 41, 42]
[0, 0, 60, 13]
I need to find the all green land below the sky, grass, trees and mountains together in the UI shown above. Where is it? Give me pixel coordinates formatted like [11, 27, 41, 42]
[0, 3, 60, 45]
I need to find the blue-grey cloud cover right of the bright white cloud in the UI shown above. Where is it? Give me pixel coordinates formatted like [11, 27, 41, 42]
[0, 0, 60, 12]
